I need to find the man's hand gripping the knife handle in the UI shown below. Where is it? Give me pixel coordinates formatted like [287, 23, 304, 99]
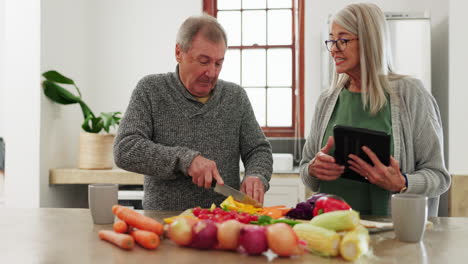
[187, 155, 224, 189]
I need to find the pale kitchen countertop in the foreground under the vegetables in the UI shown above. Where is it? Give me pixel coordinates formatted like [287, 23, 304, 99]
[0, 208, 468, 264]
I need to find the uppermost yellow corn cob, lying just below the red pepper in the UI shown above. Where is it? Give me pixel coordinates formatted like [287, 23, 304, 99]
[310, 210, 359, 231]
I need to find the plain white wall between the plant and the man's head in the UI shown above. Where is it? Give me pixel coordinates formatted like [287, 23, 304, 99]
[88, 0, 202, 115]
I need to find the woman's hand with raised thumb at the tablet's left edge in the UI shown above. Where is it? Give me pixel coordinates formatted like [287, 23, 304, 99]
[309, 136, 344, 181]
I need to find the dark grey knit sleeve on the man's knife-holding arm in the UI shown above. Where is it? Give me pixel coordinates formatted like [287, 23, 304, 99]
[114, 79, 200, 180]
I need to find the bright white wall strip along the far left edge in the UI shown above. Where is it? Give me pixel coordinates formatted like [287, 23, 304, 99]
[0, 0, 41, 207]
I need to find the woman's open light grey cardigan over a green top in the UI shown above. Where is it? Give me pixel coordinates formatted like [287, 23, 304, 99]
[300, 77, 451, 216]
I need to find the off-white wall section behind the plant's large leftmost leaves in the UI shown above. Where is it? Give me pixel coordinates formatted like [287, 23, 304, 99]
[40, 0, 93, 207]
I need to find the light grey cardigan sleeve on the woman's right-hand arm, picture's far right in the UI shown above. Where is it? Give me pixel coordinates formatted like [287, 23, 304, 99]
[407, 80, 451, 197]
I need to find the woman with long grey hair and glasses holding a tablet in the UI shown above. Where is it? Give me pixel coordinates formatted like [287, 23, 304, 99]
[300, 3, 450, 216]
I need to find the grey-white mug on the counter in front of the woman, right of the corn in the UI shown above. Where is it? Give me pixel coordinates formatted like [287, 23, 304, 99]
[392, 193, 428, 242]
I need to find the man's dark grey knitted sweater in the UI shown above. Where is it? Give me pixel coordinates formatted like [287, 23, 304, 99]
[114, 71, 273, 210]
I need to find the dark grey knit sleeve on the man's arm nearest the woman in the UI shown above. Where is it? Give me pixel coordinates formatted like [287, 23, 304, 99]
[239, 89, 273, 191]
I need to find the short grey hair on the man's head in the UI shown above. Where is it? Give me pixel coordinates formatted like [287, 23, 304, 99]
[176, 14, 227, 52]
